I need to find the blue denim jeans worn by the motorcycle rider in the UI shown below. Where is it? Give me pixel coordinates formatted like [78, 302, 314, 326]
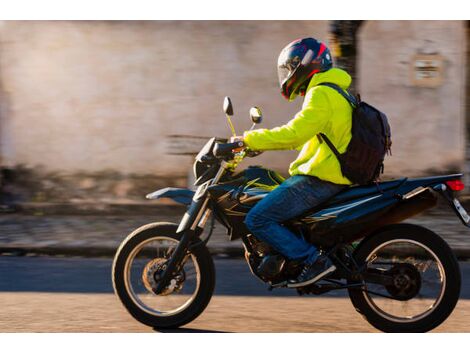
[245, 175, 346, 264]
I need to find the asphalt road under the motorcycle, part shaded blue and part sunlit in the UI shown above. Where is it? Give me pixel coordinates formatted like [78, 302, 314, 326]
[0, 257, 470, 332]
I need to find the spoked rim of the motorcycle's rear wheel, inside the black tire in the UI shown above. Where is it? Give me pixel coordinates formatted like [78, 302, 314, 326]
[363, 239, 446, 323]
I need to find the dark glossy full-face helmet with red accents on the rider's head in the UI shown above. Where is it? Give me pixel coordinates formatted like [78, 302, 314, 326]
[277, 38, 333, 101]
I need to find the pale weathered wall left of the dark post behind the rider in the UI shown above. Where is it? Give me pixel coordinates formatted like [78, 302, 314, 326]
[0, 21, 327, 199]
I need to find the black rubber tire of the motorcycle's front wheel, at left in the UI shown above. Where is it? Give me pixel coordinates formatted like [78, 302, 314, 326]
[112, 223, 215, 329]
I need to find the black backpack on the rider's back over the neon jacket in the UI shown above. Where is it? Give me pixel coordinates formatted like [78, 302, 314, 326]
[317, 83, 392, 185]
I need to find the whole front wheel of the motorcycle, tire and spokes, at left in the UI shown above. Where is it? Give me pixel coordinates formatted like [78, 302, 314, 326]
[112, 223, 215, 328]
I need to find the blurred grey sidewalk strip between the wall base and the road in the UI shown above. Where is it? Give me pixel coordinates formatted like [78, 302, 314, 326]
[0, 208, 470, 258]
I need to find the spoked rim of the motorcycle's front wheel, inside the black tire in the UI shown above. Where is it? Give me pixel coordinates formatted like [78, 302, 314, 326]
[124, 236, 201, 316]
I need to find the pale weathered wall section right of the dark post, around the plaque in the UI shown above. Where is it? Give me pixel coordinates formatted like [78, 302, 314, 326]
[359, 21, 466, 176]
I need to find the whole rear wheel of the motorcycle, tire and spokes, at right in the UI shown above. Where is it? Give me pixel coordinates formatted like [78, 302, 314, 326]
[349, 224, 461, 332]
